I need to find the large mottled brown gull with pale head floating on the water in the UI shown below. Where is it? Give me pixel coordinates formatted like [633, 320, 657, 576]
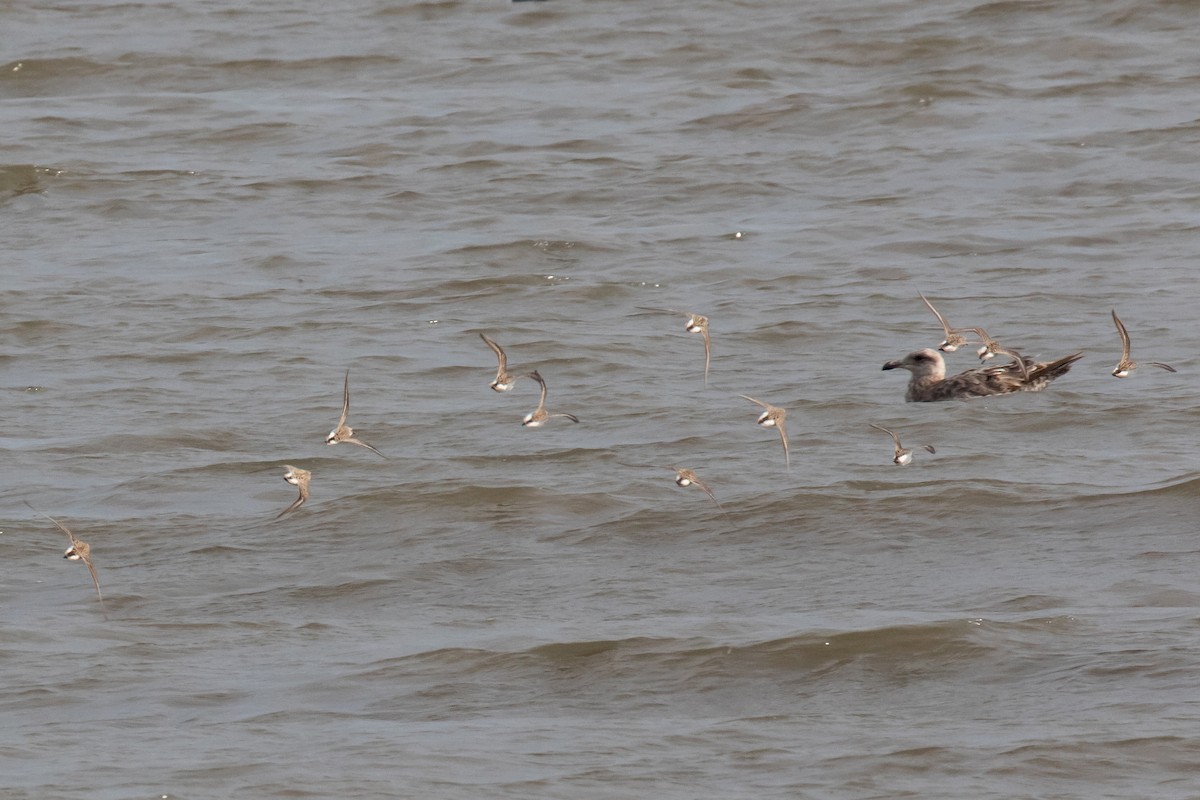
[883, 348, 1084, 403]
